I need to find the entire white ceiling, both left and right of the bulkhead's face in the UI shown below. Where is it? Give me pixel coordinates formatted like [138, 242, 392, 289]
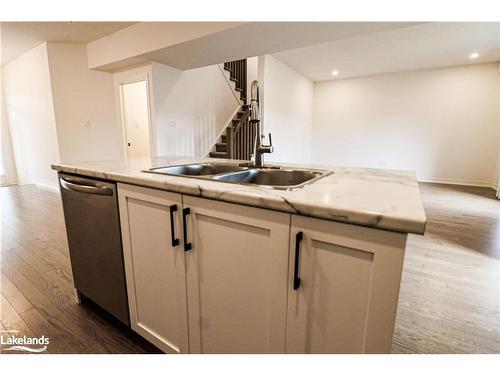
[1, 22, 500, 81]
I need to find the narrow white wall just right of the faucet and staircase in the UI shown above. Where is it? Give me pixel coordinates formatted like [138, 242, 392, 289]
[259, 55, 314, 163]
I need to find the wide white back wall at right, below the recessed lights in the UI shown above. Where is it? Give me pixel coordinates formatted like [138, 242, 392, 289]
[311, 64, 499, 186]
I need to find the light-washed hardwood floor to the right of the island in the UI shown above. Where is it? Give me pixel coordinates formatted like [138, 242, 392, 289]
[393, 184, 500, 353]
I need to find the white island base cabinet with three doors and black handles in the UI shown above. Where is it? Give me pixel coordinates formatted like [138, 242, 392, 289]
[118, 184, 407, 353]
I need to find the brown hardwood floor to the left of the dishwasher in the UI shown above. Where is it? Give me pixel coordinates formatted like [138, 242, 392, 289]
[0, 185, 154, 353]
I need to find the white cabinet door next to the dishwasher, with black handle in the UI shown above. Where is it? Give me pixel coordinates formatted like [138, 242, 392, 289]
[118, 184, 189, 353]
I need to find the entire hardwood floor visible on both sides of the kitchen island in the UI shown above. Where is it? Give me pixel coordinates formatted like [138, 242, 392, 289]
[0, 184, 500, 353]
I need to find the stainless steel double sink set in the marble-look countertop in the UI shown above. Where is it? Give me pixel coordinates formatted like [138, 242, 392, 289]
[145, 162, 333, 190]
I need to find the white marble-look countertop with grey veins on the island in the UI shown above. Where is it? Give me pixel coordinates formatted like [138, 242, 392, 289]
[52, 157, 426, 234]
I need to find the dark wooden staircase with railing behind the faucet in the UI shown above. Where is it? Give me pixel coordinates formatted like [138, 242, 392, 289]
[209, 59, 255, 160]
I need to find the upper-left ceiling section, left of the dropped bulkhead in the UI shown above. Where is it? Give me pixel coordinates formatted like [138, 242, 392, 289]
[1, 22, 135, 65]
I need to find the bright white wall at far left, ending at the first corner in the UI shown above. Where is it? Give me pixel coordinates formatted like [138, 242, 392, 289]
[2, 43, 59, 186]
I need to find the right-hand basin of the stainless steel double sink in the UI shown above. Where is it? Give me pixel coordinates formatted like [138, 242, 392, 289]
[214, 168, 331, 189]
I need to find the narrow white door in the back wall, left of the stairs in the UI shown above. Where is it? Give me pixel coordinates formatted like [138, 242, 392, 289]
[121, 81, 151, 157]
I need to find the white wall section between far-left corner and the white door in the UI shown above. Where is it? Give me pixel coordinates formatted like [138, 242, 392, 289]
[48, 43, 124, 162]
